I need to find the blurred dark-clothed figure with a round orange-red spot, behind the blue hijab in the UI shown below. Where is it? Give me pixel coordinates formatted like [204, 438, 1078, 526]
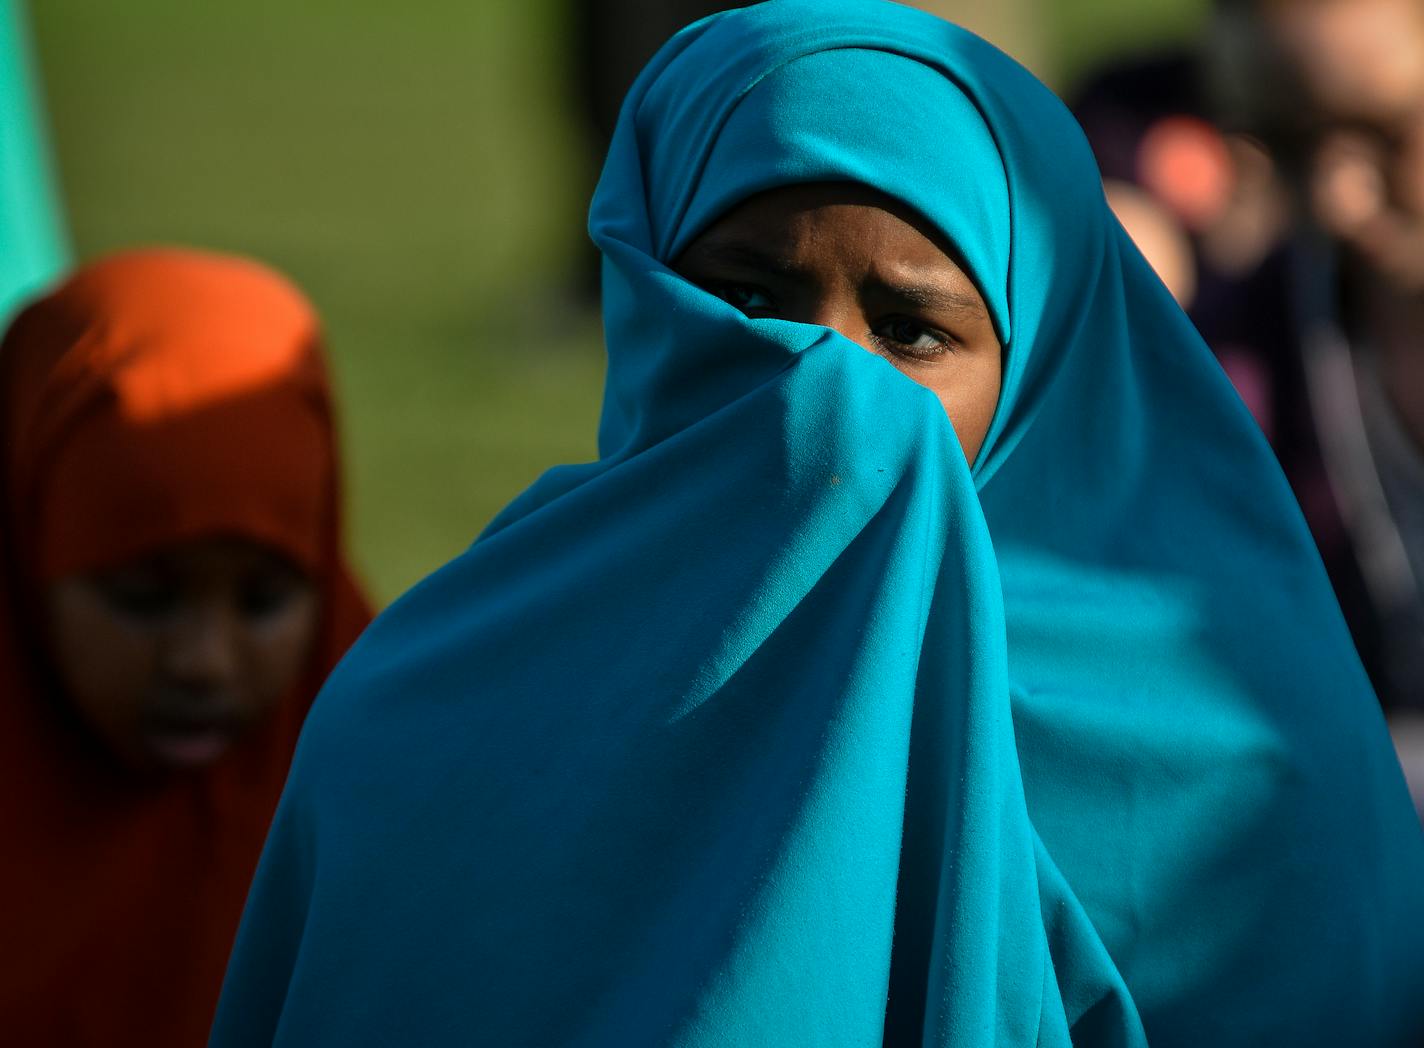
[1072, 32, 1374, 671]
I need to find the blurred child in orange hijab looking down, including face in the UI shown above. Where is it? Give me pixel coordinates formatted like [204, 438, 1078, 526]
[0, 251, 369, 1048]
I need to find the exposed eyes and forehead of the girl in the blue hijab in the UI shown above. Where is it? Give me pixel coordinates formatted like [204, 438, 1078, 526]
[672, 182, 1002, 463]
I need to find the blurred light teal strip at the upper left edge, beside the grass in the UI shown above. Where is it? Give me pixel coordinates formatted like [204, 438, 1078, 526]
[0, 0, 68, 330]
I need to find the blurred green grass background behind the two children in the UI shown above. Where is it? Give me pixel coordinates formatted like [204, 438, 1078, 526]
[30, 0, 1206, 601]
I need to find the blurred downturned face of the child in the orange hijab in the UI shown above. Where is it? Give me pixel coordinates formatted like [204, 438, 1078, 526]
[43, 538, 320, 770]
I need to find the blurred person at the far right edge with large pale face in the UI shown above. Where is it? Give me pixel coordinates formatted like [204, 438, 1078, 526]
[1223, 0, 1424, 803]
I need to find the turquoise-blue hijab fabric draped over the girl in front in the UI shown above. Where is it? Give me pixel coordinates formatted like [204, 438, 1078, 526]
[214, 0, 1424, 1048]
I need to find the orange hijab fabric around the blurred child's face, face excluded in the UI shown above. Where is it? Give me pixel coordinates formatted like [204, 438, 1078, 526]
[0, 251, 369, 1048]
